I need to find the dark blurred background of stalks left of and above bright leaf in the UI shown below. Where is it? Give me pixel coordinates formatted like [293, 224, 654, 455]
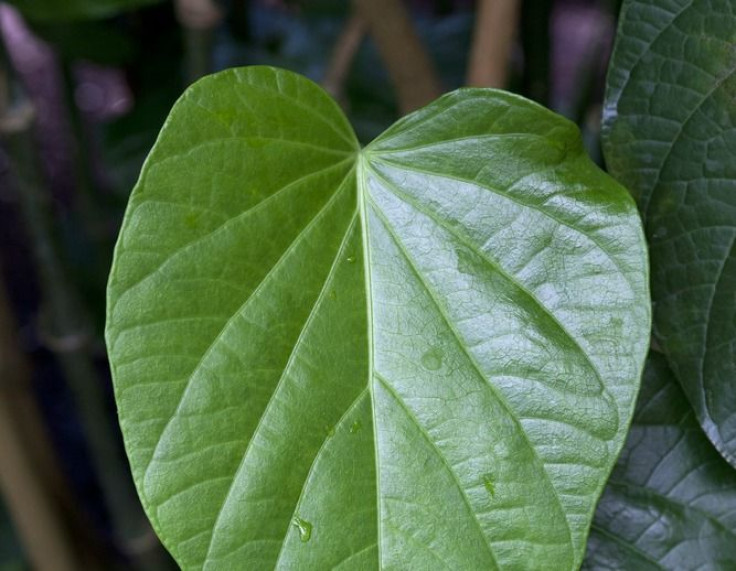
[0, 0, 618, 571]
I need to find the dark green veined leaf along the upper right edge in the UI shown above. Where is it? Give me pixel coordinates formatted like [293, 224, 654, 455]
[603, 0, 736, 465]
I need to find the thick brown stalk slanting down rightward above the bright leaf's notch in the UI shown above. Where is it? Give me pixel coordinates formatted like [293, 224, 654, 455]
[355, 0, 442, 113]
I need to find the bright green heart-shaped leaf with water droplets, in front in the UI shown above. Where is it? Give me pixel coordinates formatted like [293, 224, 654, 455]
[107, 67, 650, 570]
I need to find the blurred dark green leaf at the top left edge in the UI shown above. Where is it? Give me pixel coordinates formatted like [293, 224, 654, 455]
[8, 0, 161, 21]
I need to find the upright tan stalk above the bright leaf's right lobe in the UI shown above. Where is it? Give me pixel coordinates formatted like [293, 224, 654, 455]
[467, 0, 519, 87]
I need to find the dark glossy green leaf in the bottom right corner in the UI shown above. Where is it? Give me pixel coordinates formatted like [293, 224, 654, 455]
[584, 353, 736, 571]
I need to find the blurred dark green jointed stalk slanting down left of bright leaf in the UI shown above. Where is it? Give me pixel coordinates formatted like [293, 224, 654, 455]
[0, 31, 170, 570]
